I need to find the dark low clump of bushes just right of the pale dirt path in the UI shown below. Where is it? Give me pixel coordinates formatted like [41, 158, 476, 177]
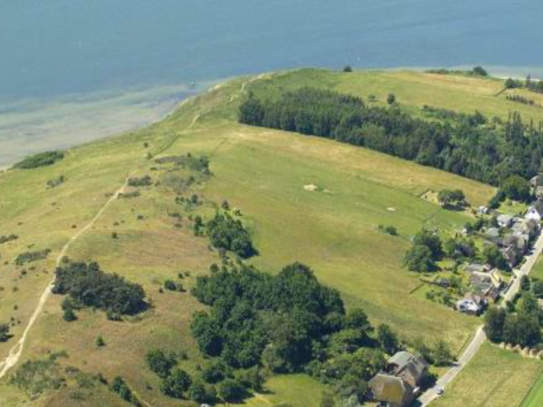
[53, 262, 146, 315]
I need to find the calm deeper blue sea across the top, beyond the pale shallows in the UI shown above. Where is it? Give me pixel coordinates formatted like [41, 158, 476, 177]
[0, 0, 543, 165]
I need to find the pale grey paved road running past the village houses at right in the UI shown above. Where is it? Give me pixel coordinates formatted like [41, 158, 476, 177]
[418, 233, 543, 407]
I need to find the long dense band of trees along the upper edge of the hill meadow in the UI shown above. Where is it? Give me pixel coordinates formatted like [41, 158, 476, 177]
[239, 88, 543, 185]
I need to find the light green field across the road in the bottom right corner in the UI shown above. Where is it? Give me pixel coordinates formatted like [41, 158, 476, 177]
[432, 343, 543, 407]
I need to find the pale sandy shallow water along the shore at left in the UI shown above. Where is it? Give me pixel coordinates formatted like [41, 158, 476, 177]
[0, 84, 209, 173]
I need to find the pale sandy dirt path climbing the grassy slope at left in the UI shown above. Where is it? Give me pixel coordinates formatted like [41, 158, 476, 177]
[0, 175, 131, 380]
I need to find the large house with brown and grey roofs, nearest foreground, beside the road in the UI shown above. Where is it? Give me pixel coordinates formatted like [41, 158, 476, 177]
[369, 352, 428, 407]
